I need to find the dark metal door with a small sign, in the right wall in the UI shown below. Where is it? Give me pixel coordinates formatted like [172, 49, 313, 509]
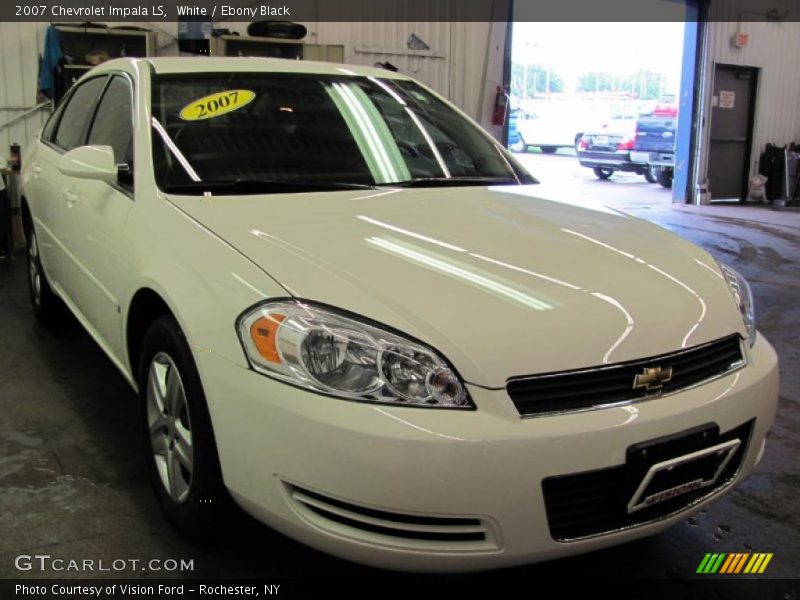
[708, 64, 758, 200]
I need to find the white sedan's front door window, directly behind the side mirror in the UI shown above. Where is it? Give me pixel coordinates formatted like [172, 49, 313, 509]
[88, 76, 133, 166]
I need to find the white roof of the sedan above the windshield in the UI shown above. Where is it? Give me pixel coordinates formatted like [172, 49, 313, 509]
[93, 56, 408, 79]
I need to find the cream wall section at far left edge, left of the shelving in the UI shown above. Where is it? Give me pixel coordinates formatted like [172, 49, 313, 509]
[0, 22, 49, 158]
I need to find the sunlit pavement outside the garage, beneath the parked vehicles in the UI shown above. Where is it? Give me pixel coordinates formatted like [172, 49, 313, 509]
[514, 148, 672, 207]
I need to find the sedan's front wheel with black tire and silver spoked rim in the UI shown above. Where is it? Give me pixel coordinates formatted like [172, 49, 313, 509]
[138, 315, 233, 539]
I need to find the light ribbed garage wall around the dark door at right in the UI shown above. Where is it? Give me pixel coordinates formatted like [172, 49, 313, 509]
[698, 0, 800, 192]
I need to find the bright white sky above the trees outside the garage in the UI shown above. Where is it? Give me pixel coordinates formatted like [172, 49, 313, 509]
[512, 21, 684, 90]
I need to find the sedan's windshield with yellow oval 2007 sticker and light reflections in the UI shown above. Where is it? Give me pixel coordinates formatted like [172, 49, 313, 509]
[152, 73, 533, 194]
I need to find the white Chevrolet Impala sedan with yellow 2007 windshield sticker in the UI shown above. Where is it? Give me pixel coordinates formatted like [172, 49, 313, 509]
[22, 58, 778, 571]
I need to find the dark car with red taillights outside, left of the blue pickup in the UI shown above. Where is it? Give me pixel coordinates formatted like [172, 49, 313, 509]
[578, 120, 656, 183]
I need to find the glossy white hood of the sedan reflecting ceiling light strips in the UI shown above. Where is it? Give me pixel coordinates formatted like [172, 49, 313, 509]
[168, 185, 744, 388]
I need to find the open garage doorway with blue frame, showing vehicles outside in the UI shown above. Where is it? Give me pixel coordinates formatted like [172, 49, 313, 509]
[507, 0, 698, 205]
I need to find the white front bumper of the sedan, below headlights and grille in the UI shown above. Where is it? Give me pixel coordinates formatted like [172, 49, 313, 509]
[197, 336, 778, 571]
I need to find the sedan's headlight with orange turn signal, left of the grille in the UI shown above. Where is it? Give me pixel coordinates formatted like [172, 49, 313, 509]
[237, 301, 474, 408]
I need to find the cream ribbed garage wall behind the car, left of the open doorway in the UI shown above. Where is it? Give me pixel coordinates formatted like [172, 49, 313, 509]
[0, 17, 505, 155]
